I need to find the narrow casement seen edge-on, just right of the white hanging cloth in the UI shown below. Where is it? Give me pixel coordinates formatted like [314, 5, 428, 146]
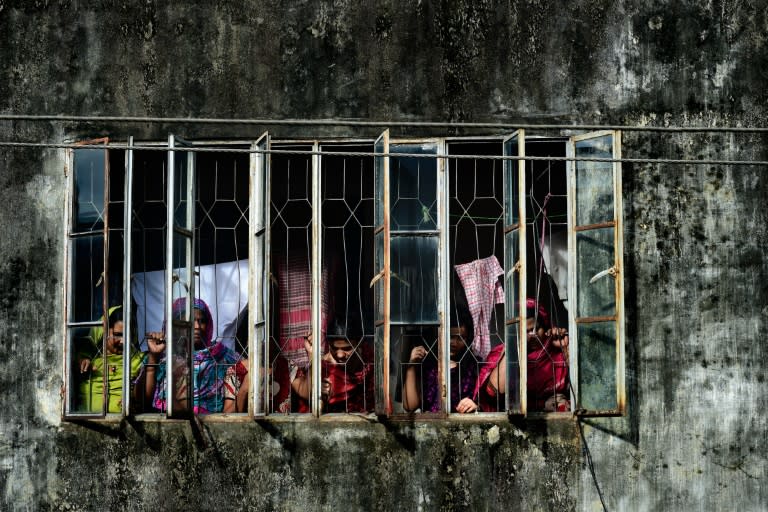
[248, 133, 270, 416]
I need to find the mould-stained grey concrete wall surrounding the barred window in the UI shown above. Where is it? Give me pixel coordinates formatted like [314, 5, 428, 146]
[0, 0, 768, 510]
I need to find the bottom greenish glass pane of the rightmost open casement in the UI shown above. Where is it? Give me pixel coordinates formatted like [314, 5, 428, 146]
[577, 322, 618, 411]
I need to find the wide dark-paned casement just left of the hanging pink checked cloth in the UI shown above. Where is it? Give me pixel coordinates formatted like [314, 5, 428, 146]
[384, 140, 449, 415]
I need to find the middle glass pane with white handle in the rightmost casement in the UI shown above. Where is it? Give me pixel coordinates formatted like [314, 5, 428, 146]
[576, 228, 616, 317]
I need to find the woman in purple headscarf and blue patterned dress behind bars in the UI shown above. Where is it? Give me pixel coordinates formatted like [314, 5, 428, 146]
[145, 298, 248, 414]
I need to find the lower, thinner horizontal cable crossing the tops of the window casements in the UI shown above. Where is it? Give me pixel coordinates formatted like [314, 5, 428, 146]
[0, 141, 768, 166]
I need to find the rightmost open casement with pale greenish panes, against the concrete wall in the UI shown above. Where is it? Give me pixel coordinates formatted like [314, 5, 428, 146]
[568, 131, 625, 415]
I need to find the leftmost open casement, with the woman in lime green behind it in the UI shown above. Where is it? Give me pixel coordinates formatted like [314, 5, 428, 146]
[64, 138, 112, 417]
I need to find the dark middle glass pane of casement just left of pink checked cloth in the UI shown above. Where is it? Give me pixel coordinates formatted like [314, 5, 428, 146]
[390, 236, 438, 323]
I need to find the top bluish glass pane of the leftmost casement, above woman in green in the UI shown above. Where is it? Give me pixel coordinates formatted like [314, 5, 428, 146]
[73, 149, 106, 233]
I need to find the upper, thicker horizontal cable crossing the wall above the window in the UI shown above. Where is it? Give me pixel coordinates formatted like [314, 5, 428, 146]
[0, 114, 768, 133]
